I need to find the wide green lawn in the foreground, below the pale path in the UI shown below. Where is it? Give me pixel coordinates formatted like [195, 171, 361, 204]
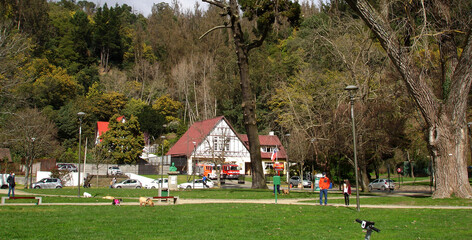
[0, 204, 472, 239]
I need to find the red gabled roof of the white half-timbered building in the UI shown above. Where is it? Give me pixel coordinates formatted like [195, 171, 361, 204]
[166, 116, 242, 157]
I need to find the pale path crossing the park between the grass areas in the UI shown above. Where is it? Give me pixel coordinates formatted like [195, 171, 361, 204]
[0, 189, 472, 209]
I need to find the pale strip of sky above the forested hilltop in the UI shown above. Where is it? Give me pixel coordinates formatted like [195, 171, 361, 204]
[87, 0, 202, 17]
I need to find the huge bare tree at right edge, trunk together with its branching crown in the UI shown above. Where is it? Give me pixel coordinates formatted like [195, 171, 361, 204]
[347, 0, 472, 198]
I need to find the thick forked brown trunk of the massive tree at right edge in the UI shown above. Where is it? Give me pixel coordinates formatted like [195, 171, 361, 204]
[347, 0, 472, 198]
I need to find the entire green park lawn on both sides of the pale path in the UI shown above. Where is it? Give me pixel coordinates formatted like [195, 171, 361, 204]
[0, 188, 472, 240]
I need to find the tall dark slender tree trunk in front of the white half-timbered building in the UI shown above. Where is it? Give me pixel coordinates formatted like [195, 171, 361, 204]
[230, 0, 267, 189]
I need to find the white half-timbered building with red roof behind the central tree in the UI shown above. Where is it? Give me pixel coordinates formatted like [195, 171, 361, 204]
[166, 116, 287, 175]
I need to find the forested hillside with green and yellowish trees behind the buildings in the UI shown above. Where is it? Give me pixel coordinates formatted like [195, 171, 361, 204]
[0, 0, 470, 196]
